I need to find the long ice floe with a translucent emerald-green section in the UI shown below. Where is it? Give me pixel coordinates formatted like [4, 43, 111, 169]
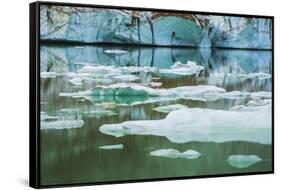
[59, 83, 271, 105]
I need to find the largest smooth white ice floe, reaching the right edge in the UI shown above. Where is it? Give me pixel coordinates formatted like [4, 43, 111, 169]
[99, 105, 271, 144]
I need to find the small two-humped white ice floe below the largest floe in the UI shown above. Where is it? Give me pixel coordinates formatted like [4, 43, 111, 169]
[150, 149, 201, 159]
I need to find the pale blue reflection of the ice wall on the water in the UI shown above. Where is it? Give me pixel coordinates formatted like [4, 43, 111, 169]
[40, 46, 272, 91]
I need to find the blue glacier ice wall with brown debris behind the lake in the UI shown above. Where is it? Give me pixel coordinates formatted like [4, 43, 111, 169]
[40, 5, 272, 49]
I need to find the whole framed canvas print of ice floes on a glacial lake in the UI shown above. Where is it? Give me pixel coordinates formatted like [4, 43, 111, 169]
[30, 2, 274, 188]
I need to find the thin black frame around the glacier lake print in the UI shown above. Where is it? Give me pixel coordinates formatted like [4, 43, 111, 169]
[29, 1, 275, 188]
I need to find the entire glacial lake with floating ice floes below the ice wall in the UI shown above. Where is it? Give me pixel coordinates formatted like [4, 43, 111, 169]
[40, 44, 272, 185]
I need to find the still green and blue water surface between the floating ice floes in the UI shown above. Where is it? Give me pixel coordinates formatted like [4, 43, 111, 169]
[40, 45, 272, 184]
